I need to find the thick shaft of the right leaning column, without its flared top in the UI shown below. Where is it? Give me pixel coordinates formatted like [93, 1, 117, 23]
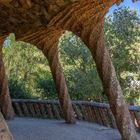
[83, 23, 137, 140]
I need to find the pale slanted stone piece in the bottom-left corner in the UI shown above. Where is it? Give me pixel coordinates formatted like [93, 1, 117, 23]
[0, 112, 14, 140]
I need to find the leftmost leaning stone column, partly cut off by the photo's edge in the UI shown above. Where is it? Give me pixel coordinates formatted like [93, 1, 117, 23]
[0, 44, 14, 119]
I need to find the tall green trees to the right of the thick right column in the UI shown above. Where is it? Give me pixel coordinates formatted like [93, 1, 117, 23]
[105, 7, 140, 103]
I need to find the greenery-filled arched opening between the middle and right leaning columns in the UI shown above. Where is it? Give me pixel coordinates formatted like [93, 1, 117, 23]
[59, 31, 107, 102]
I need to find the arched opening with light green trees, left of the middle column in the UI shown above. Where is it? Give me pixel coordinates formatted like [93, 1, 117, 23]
[3, 34, 56, 99]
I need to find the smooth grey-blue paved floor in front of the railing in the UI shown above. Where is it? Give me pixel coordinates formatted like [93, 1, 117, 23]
[8, 118, 140, 140]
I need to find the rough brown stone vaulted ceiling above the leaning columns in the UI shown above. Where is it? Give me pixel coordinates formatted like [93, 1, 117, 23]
[0, 0, 138, 37]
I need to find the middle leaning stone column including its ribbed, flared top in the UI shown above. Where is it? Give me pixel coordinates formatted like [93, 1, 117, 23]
[22, 27, 75, 123]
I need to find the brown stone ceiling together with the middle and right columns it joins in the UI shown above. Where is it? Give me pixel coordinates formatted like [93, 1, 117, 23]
[0, 0, 137, 140]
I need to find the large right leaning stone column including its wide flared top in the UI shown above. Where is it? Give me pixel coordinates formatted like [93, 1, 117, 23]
[49, 1, 137, 140]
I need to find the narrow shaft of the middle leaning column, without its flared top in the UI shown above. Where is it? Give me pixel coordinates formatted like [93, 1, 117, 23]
[45, 44, 75, 123]
